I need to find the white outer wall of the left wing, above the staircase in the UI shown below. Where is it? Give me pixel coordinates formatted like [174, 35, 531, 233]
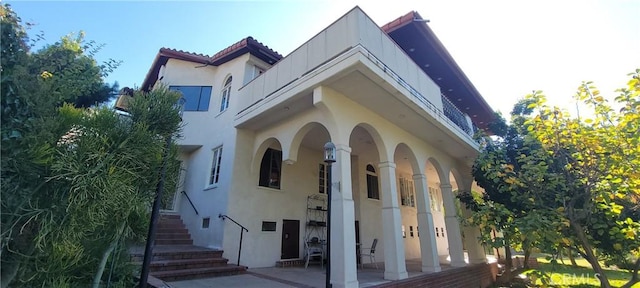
[161, 55, 260, 248]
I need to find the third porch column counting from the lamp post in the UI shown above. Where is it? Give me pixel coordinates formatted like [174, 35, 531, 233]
[413, 174, 442, 272]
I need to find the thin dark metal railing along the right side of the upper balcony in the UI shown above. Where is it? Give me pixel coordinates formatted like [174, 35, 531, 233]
[360, 46, 477, 143]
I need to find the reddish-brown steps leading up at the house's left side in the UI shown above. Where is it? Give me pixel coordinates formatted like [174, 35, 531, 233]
[130, 214, 246, 281]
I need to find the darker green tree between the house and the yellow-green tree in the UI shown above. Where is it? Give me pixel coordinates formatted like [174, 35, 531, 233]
[459, 105, 561, 281]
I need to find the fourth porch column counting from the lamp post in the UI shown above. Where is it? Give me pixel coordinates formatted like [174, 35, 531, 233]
[440, 184, 467, 267]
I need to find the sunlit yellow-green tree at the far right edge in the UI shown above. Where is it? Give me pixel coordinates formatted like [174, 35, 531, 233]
[528, 69, 640, 287]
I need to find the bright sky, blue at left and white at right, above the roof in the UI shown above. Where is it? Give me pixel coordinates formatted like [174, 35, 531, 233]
[5, 0, 640, 113]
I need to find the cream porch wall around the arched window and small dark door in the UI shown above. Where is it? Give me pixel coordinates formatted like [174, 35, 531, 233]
[224, 111, 336, 267]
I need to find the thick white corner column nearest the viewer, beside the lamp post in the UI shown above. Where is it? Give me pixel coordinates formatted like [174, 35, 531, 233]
[330, 144, 359, 288]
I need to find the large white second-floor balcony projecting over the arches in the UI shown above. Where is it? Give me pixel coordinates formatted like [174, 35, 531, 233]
[234, 8, 486, 158]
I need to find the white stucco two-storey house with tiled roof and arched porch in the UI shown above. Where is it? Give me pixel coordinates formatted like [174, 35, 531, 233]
[142, 7, 494, 287]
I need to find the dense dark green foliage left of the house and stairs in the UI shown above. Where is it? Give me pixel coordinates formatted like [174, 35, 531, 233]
[0, 5, 180, 287]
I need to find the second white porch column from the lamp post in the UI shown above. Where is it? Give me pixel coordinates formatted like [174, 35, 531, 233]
[378, 162, 409, 280]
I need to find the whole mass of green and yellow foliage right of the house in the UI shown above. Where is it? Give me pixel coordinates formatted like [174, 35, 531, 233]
[461, 70, 640, 287]
